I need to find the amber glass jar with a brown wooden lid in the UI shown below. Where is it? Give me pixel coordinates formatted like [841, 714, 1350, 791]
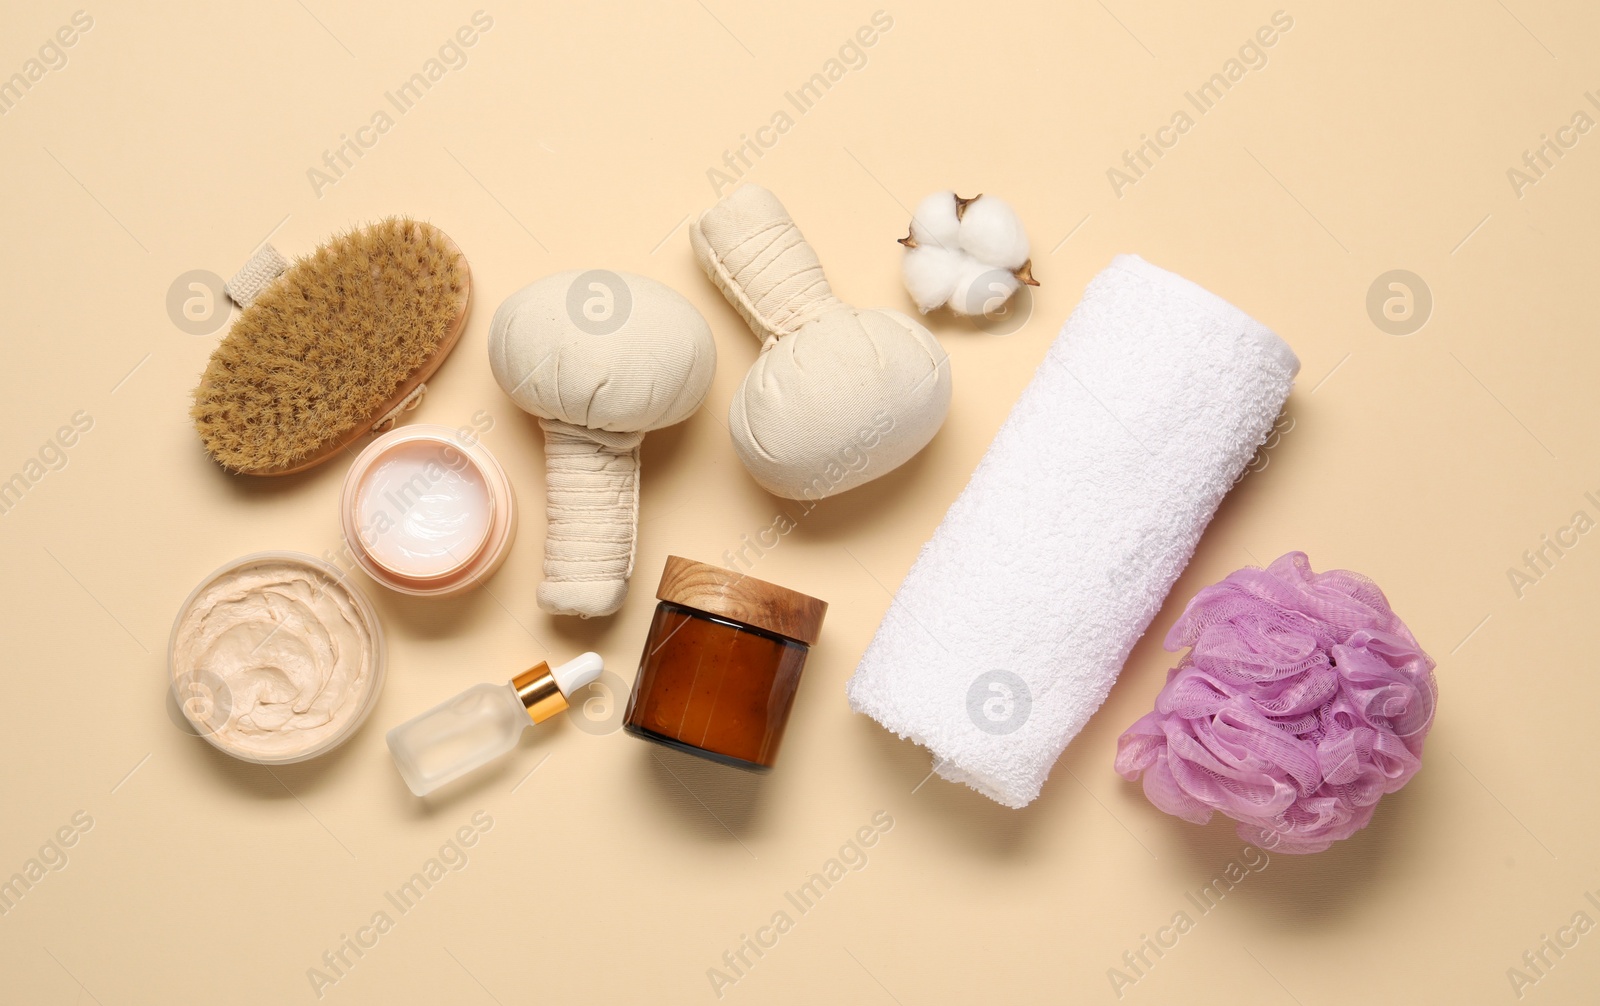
[624, 555, 827, 771]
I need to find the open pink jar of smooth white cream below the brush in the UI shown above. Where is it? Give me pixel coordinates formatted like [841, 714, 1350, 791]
[339, 424, 517, 597]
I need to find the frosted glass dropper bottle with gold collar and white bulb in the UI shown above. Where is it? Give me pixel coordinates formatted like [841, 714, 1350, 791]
[389, 653, 605, 796]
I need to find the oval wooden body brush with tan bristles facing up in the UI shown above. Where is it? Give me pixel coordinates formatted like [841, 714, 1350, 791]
[189, 218, 467, 472]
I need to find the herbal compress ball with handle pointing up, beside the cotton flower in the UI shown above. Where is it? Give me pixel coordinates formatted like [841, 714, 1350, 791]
[690, 186, 950, 499]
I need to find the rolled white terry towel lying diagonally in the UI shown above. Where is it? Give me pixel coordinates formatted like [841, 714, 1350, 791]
[848, 254, 1299, 808]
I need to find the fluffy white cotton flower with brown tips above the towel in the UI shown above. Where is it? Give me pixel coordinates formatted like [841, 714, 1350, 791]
[901, 192, 1038, 315]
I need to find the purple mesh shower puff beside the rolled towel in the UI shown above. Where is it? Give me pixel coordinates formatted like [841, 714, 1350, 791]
[1117, 552, 1438, 852]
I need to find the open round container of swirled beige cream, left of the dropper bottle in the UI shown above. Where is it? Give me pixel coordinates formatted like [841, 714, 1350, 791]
[173, 558, 376, 761]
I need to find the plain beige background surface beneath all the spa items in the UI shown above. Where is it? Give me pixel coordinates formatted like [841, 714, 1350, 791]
[0, 0, 1600, 1006]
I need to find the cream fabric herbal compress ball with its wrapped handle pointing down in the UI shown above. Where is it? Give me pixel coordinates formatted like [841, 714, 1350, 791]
[490, 269, 717, 617]
